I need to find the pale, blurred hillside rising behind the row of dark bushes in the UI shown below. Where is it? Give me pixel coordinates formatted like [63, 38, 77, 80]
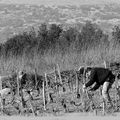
[0, 0, 120, 42]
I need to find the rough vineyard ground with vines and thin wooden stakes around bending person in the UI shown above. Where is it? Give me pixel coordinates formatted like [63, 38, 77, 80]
[1, 63, 120, 116]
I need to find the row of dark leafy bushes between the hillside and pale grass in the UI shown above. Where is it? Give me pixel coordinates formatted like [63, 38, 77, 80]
[0, 21, 114, 62]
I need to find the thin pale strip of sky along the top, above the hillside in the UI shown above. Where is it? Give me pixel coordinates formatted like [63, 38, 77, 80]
[0, 0, 120, 5]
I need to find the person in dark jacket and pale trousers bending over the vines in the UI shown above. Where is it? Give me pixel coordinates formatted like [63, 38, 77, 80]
[83, 67, 115, 105]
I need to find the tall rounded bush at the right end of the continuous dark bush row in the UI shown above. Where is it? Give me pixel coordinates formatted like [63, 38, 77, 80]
[81, 21, 104, 49]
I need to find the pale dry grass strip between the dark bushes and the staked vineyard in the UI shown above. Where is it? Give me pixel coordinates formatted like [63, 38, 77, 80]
[0, 47, 120, 74]
